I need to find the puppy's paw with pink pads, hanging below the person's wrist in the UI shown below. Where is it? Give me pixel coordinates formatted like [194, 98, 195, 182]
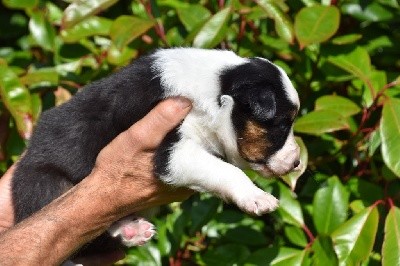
[108, 218, 156, 247]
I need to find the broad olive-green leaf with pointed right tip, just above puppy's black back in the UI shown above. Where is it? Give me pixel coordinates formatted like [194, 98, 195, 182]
[110, 15, 155, 50]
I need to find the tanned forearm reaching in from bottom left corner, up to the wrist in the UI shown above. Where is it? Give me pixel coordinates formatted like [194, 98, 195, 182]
[0, 171, 124, 265]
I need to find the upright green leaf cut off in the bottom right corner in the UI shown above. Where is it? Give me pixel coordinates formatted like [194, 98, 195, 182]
[382, 206, 400, 266]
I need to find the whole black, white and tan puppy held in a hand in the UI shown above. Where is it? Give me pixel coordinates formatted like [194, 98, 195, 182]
[12, 48, 300, 251]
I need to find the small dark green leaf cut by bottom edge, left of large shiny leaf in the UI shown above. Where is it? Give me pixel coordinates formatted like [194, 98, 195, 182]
[312, 235, 338, 265]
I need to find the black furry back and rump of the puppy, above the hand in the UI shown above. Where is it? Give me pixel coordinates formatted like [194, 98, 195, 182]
[12, 55, 162, 222]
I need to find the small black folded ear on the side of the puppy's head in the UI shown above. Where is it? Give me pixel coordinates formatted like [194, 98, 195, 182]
[238, 86, 276, 122]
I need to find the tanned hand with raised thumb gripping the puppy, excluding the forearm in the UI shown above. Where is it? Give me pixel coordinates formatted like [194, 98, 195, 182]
[91, 98, 193, 217]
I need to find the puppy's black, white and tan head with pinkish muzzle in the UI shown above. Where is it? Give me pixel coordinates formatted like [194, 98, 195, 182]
[221, 58, 300, 176]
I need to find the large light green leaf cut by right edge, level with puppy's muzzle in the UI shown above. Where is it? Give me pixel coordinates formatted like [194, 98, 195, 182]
[380, 98, 400, 177]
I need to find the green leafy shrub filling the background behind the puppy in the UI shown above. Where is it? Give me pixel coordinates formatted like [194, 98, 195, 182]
[0, 0, 400, 265]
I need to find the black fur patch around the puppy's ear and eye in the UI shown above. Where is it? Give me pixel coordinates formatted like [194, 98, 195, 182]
[220, 58, 297, 161]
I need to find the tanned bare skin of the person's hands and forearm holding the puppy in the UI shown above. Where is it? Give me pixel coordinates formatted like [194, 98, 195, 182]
[0, 98, 193, 265]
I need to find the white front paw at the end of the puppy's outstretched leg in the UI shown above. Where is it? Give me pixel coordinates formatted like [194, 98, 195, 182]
[238, 191, 279, 216]
